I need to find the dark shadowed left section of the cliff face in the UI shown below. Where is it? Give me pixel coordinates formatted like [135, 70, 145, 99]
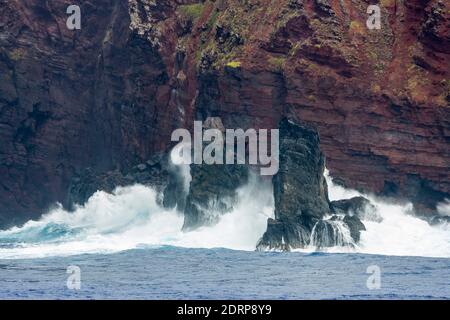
[0, 0, 186, 223]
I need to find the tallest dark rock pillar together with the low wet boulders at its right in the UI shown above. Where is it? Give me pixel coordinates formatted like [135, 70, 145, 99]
[257, 119, 371, 250]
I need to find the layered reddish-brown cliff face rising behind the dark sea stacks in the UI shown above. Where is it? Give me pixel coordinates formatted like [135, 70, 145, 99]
[0, 0, 450, 223]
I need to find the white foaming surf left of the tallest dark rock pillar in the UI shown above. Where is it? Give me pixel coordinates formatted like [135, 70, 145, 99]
[0, 178, 273, 259]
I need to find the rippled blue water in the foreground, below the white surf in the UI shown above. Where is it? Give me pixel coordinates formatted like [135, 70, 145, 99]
[0, 247, 450, 299]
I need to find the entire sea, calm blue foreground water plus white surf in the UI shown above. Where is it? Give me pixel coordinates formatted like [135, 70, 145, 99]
[0, 171, 450, 299]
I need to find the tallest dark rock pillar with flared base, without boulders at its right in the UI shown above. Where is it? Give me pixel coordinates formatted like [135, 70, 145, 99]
[257, 119, 330, 249]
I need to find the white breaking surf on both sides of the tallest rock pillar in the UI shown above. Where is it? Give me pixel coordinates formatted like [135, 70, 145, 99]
[0, 164, 450, 259]
